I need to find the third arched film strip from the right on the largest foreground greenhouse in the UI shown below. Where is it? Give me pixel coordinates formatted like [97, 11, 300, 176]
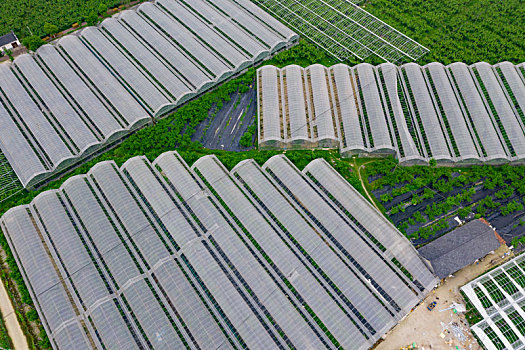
[234, 161, 394, 339]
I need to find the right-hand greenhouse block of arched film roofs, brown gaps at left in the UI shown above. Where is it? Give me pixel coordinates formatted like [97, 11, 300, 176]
[257, 62, 525, 164]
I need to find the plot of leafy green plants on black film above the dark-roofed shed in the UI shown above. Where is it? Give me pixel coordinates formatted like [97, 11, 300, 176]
[366, 160, 525, 245]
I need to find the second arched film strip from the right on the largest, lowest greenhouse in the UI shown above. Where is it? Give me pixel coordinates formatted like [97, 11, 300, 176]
[264, 156, 428, 315]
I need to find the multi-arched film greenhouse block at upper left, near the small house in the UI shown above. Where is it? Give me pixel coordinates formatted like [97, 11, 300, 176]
[0, 0, 298, 188]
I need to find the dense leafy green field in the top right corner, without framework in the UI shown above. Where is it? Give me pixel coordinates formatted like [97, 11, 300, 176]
[364, 0, 525, 64]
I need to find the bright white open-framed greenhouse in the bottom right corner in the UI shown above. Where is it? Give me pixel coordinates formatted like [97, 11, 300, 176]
[461, 255, 525, 350]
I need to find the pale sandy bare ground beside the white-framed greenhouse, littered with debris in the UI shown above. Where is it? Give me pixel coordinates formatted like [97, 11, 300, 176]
[375, 246, 513, 350]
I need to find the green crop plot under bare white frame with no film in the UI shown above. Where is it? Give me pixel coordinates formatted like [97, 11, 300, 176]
[252, 0, 428, 62]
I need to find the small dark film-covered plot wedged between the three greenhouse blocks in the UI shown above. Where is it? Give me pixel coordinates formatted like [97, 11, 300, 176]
[192, 84, 257, 152]
